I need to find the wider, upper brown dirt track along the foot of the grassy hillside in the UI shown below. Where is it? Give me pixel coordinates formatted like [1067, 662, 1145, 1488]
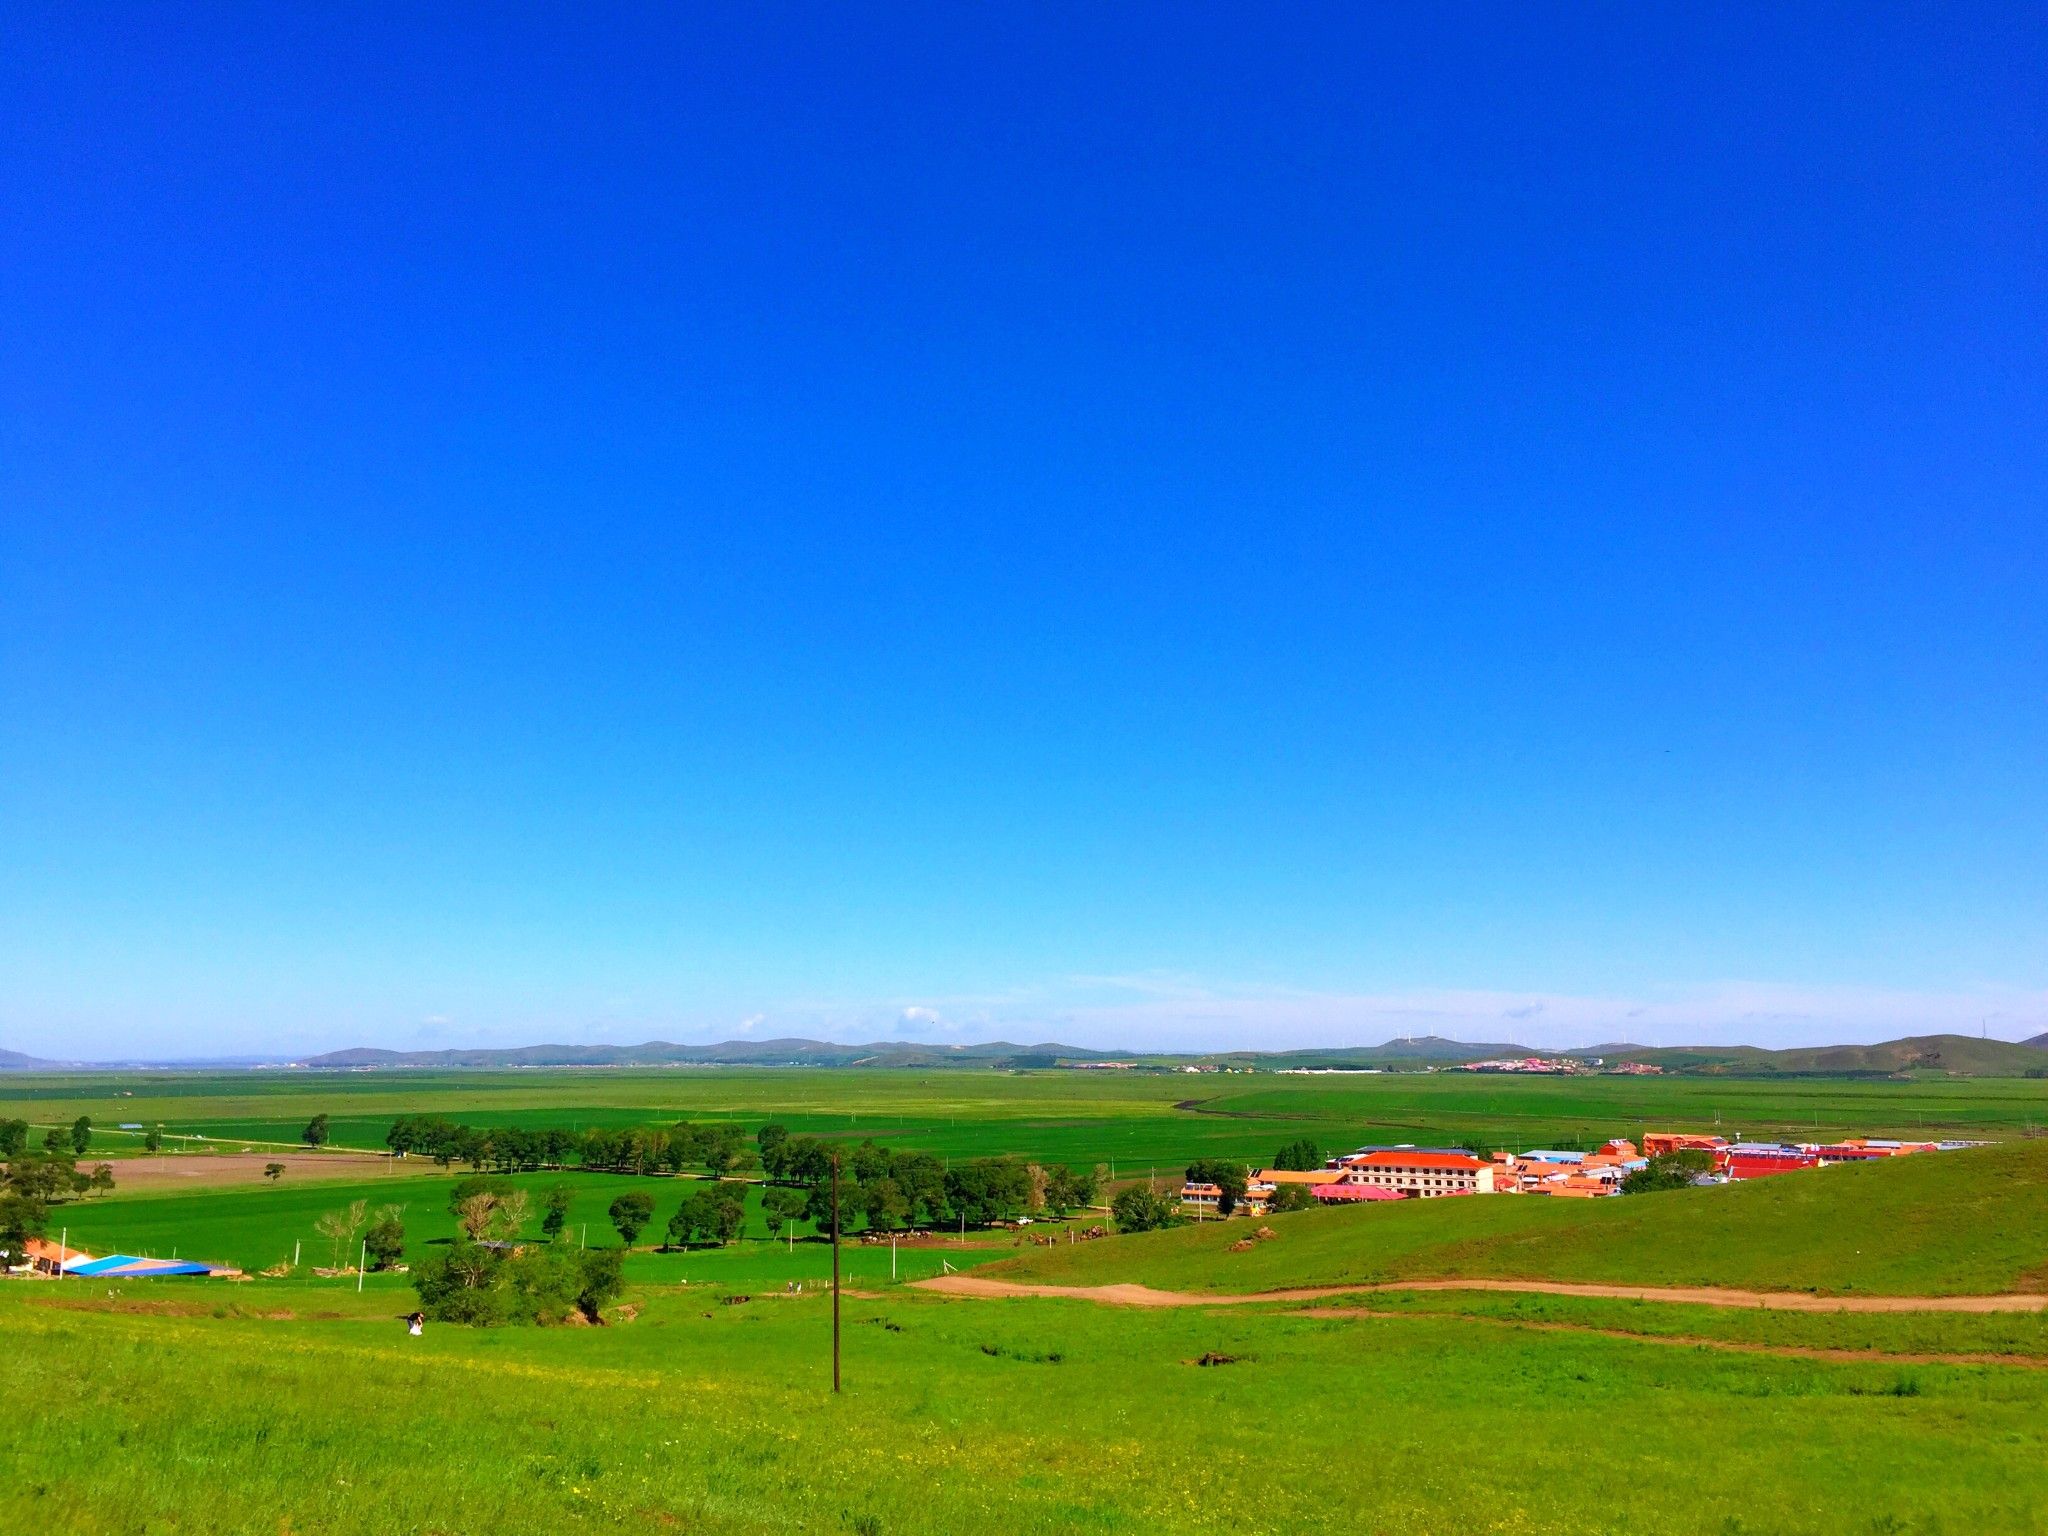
[911, 1274, 2048, 1337]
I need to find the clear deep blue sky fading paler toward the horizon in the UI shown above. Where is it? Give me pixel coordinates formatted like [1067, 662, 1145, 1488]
[0, 6, 2048, 1057]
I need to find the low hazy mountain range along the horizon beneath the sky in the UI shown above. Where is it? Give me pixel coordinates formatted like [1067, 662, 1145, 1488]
[0, 1034, 2048, 1077]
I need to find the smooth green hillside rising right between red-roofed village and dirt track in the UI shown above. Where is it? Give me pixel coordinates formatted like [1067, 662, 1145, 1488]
[985, 1141, 2048, 1294]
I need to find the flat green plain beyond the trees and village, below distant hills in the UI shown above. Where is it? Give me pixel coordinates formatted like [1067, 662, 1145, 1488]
[12, 1067, 2048, 1174]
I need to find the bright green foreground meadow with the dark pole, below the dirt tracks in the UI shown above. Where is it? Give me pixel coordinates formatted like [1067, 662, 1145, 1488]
[0, 1286, 2048, 1536]
